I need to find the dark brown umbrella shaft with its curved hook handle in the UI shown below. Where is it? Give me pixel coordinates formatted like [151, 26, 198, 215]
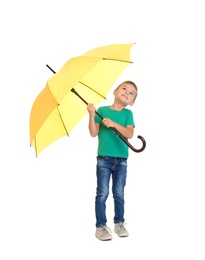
[71, 88, 146, 153]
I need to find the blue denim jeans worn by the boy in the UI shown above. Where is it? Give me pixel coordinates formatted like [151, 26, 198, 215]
[95, 155, 127, 227]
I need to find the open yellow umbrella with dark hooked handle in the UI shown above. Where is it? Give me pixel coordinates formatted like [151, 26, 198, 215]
[30, 44, 145, 156]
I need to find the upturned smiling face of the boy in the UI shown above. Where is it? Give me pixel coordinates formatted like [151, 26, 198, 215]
[114, 83, 137, 106]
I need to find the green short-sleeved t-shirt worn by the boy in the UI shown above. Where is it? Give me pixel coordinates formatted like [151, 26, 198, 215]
[95, 106, 134, 158]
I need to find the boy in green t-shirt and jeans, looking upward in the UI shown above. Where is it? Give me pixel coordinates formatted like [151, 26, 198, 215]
[87, 81, 137, 241]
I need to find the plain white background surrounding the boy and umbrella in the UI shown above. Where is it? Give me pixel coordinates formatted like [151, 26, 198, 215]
[0, 0, 205, 260]
